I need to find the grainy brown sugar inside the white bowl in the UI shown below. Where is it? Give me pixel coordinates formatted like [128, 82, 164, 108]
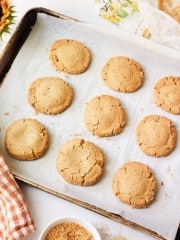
[45, 223, 94, 240]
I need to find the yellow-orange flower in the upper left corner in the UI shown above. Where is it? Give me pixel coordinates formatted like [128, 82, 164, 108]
[0, 0, 14, 38]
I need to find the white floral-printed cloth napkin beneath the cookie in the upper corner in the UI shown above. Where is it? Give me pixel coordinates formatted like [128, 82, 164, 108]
[95, 0, 180, 50]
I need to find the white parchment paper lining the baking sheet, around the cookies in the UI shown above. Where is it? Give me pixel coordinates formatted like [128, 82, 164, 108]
[0, 14, 180, 239]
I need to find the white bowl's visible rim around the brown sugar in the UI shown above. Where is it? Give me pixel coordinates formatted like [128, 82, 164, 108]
[39, 217, 101, 240]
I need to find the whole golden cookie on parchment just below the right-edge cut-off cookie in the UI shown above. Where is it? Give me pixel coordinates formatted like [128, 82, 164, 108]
[136, 115, 176, 157]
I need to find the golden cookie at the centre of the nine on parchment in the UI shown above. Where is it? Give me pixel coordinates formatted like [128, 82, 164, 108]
[84, 95, 126, 137]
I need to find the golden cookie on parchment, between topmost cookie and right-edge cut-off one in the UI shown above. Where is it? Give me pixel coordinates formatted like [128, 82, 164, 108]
[101, 57, 144, 93]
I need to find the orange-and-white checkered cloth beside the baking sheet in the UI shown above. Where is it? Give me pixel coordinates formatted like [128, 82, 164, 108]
[0, 156, 35, 240]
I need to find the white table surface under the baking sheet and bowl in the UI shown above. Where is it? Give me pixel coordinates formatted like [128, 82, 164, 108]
[0, 0, 177, 240]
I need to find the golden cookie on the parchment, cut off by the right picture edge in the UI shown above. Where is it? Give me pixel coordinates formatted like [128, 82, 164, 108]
[154, 76, 180, 114]
